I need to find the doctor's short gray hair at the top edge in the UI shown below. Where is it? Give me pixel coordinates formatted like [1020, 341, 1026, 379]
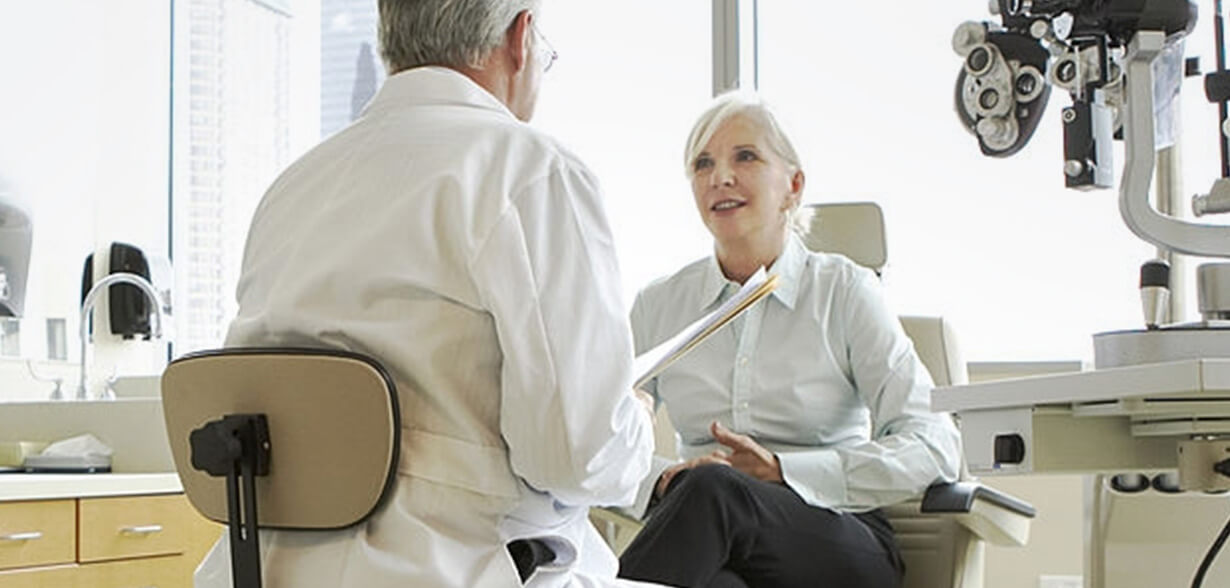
[380, 0, 540, 74]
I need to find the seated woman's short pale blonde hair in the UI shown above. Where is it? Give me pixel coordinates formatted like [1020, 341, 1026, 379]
[684, 90, 803, 177]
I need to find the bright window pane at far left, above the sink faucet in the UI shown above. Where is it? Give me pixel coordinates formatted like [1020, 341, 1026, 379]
[0, 0, 170, 364]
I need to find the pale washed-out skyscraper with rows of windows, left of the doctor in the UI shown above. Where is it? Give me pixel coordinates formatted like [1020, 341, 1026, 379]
[173, 0, 292, 354]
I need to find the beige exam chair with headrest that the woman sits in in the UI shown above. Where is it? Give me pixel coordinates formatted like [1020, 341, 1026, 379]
[590, 203, 1036, 588]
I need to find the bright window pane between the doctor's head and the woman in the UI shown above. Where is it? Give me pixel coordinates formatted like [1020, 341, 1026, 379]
[533, 0, 712, 305]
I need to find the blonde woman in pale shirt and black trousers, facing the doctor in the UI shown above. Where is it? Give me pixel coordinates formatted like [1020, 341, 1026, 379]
[620, 93, 961, 588]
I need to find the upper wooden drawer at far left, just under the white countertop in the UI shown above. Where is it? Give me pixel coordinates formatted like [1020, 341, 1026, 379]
[0, 501, 76, 570]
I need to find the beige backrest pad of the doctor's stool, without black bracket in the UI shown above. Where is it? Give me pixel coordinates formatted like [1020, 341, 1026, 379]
[162, 348, 400, 529]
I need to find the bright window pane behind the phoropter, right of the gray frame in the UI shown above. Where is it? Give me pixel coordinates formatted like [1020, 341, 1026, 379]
[759, 0, 1216, 360]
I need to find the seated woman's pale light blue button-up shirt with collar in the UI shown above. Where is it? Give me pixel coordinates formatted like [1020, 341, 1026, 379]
[632, 235, 961, 513]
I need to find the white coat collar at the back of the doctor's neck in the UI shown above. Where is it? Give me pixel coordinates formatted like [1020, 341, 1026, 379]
[363, 65, 515, 118]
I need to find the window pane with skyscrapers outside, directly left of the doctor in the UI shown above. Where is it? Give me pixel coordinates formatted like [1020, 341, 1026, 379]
[172, 0, 384, 354]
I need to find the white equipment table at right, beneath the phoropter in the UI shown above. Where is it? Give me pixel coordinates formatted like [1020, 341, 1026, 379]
[932, 359, 1230, 588]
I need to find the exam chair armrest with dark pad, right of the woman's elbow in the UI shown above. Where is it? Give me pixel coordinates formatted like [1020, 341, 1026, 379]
[920, 482, 1038, 546]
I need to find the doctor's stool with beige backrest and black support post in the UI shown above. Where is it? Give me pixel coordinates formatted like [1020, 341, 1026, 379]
[162, 348, 401, 588]
